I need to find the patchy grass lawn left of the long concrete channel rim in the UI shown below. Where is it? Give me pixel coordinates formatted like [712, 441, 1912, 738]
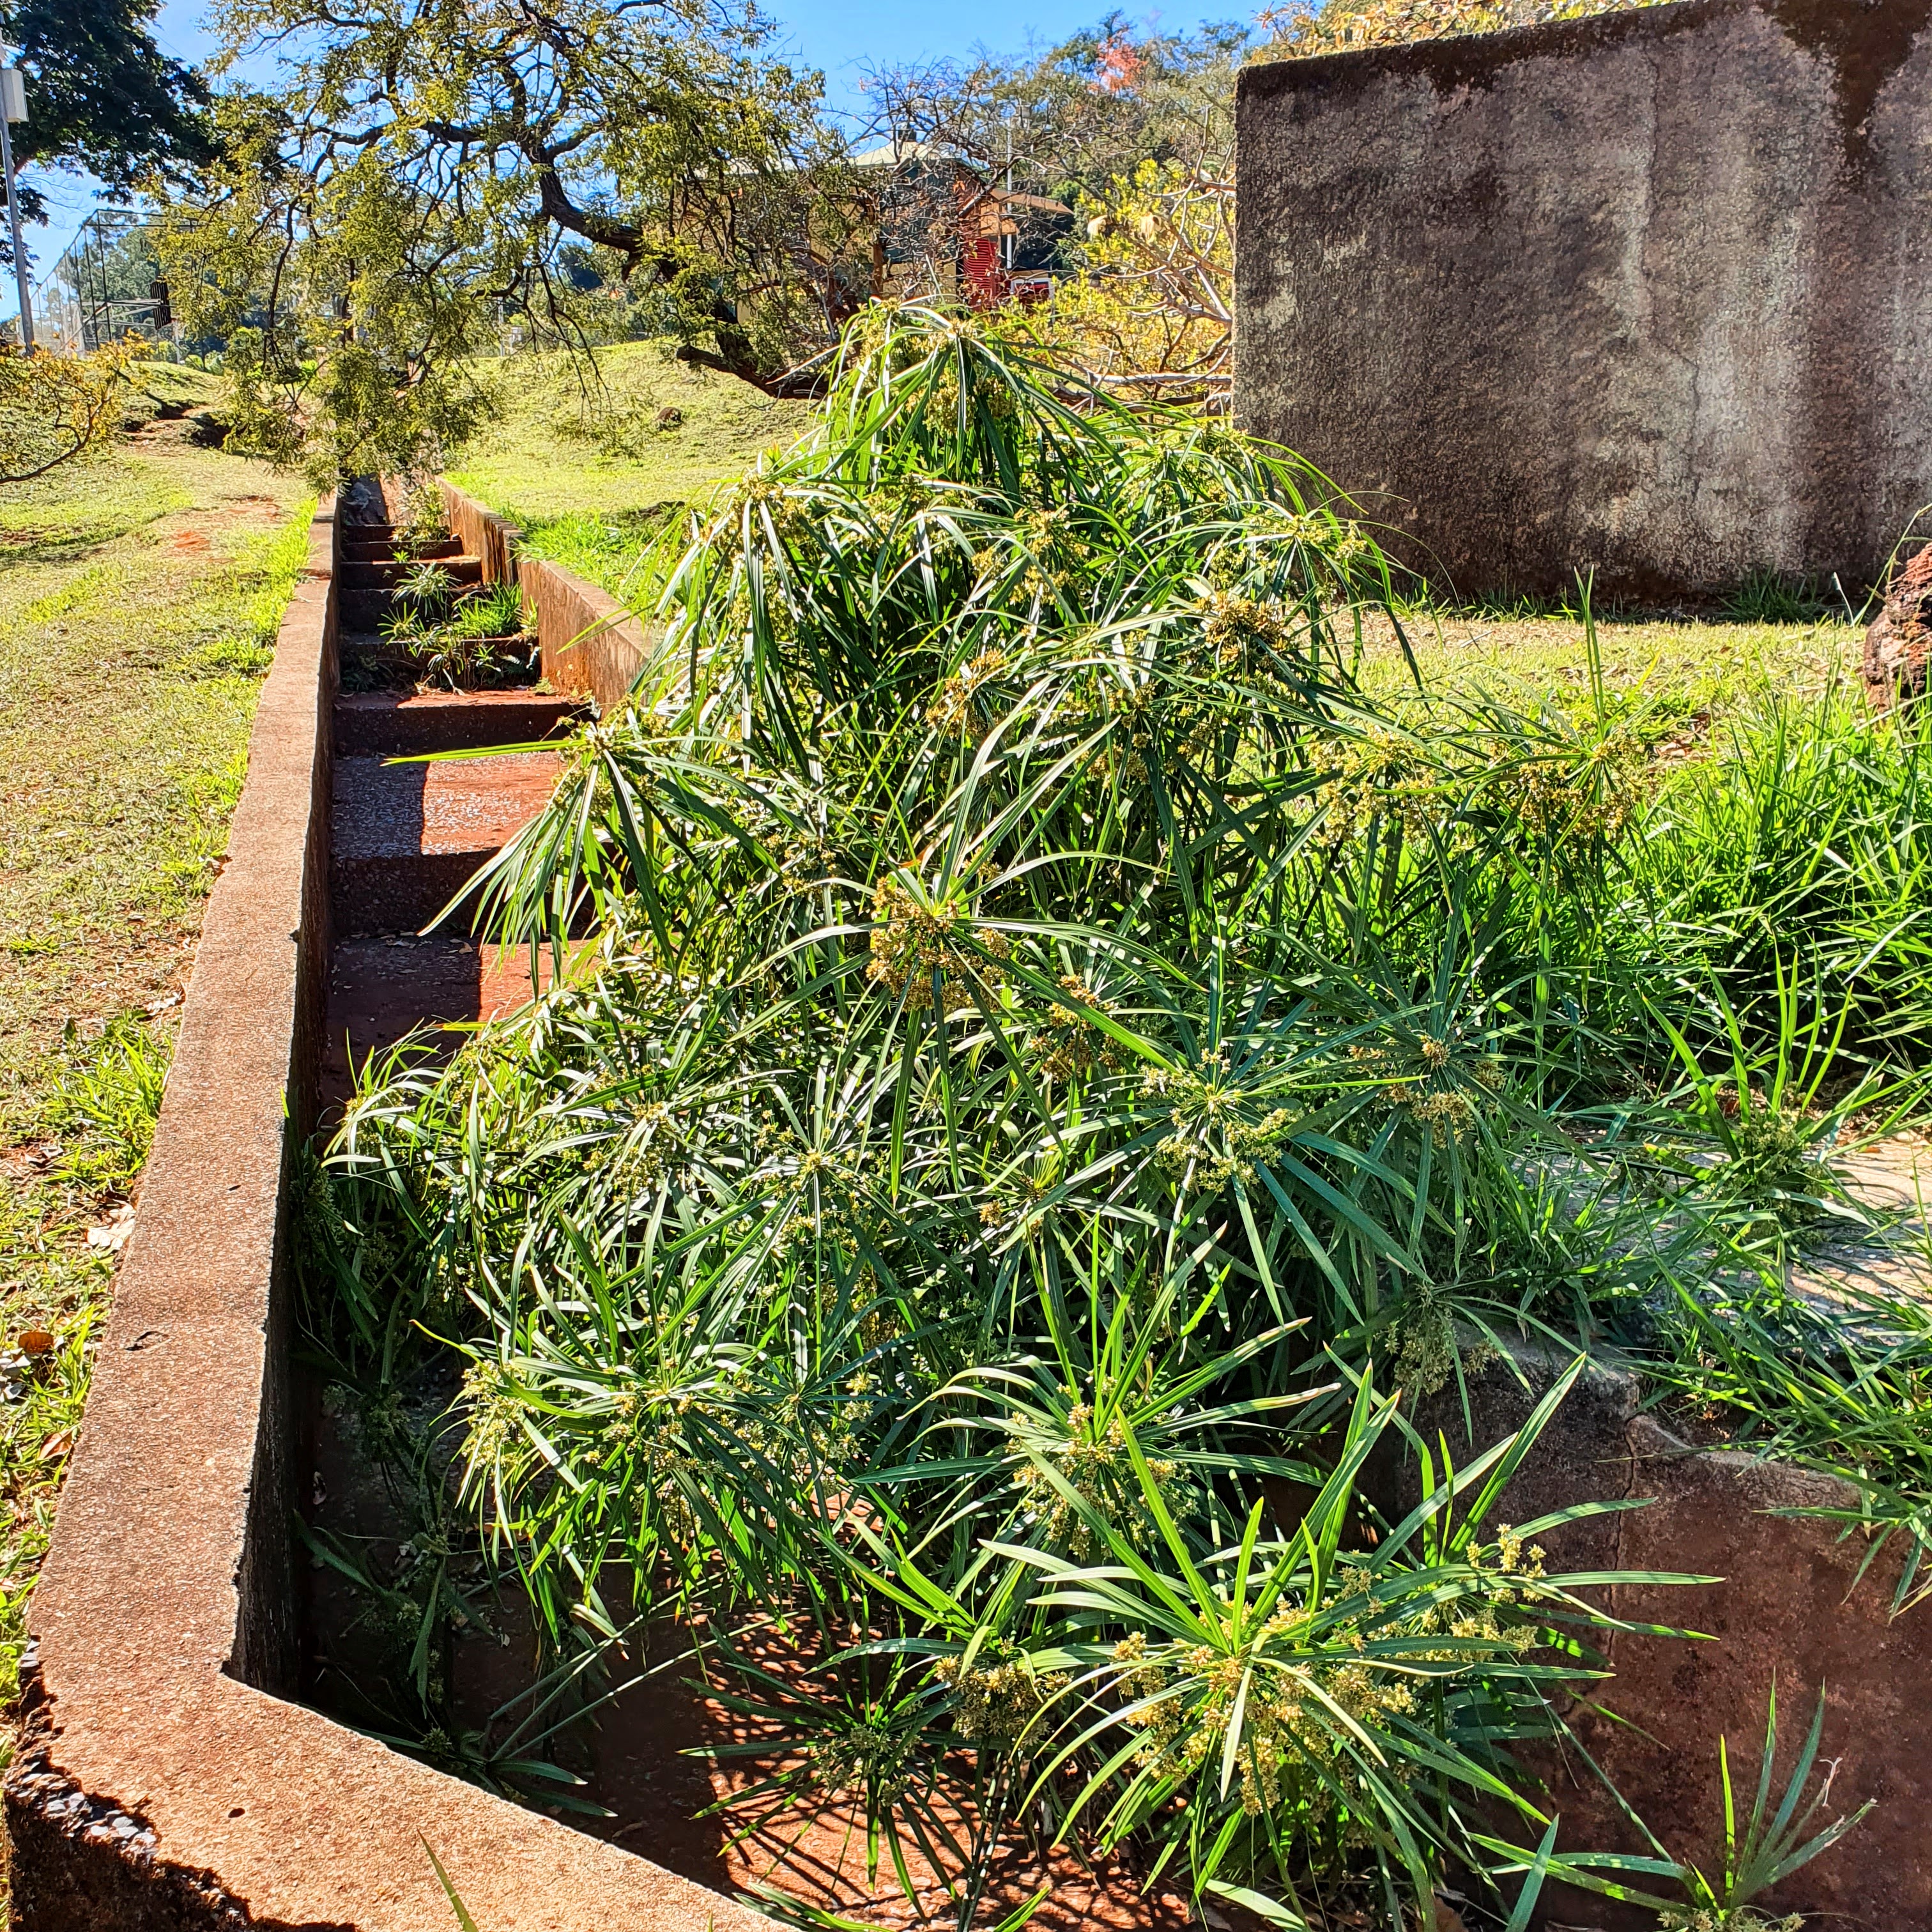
[0, 423, 305, 1754]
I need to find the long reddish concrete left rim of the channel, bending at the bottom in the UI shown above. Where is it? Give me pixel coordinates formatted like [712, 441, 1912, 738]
[6, 500, 761, 1932]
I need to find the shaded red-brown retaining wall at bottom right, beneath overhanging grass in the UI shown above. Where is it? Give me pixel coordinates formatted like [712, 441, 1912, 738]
[1391, 1353, 1932, 1932]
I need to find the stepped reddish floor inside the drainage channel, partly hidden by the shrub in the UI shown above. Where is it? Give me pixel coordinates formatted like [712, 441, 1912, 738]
[298, 487, 1205, 1932]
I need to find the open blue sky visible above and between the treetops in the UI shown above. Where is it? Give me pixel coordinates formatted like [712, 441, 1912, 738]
[11, 0, 1240, 319]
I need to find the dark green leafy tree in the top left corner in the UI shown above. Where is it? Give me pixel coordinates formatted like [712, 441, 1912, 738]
[4, 0, 215, 220]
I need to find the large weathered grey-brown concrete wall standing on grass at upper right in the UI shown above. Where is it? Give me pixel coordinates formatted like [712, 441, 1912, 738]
[1234, 0, 1932, 597]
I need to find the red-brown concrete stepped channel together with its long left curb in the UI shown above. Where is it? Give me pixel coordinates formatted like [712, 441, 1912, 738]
[6, 487, 759, 1932]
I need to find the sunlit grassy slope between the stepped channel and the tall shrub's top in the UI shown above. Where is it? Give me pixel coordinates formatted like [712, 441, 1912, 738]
[448, 342, 811, 595]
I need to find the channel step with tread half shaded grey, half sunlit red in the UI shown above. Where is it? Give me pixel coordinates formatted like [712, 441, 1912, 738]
[328, 751, 562, 939]
